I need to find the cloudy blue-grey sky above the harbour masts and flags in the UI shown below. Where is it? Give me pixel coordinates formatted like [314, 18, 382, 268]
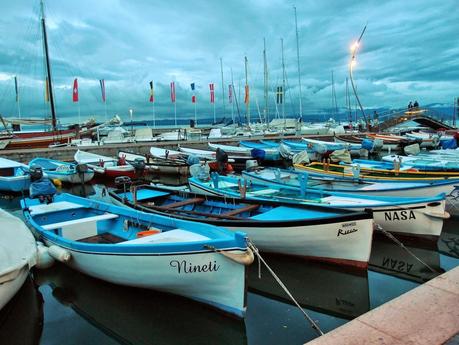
[0, 0, 459, 122]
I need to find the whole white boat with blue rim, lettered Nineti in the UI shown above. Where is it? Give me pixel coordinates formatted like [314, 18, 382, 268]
[21, 194, 253, 317]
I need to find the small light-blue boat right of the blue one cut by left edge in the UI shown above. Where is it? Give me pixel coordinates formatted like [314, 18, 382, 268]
[29, 158, 94, 184]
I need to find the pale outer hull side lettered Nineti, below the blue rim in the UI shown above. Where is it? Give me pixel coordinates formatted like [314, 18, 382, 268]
[41, 240, 246, 317]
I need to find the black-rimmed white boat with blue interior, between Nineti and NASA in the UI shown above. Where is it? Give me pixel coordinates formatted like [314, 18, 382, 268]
[109, 185, 373, 268]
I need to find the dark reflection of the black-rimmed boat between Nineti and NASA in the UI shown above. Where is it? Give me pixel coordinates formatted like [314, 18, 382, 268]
[249, 255, 370, 320]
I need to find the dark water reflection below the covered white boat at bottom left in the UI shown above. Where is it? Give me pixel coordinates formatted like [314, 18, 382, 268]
[0, 276, 43, 345]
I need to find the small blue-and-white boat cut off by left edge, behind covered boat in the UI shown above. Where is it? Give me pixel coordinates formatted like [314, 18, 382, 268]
[0, 157, 30, 192]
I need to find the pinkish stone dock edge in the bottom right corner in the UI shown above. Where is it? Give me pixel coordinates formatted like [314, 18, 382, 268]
[307, 267, 459, 345]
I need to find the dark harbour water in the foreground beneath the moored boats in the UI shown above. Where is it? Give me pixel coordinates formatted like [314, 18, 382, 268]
[0, 186, 459, 345]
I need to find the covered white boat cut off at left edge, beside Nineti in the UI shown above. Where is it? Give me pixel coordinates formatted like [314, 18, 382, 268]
[0, 209, 37, 309]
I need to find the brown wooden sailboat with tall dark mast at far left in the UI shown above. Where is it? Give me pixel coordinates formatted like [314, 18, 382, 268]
[0, 0, 90, 149]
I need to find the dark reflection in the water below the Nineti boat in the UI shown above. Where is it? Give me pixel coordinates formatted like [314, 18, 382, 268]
[37, 264, 247, 344]
